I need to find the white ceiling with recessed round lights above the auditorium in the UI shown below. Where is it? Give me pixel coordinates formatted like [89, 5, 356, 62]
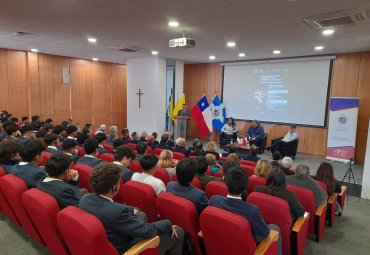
[0, 0, 370, 63]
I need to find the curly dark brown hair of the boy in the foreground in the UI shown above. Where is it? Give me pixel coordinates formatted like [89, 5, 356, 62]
[90, 162, 122, 194]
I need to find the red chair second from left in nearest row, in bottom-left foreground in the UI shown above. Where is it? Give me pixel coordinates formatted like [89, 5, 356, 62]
[22, 189, 70, 255]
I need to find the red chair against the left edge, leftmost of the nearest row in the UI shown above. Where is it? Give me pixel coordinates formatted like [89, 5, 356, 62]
[0, 174, 44, 244]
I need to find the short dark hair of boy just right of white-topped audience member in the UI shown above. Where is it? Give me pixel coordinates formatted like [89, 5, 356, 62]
[176, 158, 198, 186]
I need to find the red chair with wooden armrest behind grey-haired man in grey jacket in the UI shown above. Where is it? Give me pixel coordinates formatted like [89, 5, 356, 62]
[287, 185, 326, 242]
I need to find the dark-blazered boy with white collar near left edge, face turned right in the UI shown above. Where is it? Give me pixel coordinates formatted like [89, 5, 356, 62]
[11, 139, 46, 189]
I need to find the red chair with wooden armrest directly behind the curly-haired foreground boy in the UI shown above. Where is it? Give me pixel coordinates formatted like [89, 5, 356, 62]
[57, 206, 159, 255]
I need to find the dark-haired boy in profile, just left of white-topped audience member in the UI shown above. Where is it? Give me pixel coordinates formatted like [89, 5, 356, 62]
[113, 145, 135, 182]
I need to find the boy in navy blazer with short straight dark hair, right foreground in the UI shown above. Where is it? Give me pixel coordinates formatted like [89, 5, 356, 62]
[209, 167, 281, 254]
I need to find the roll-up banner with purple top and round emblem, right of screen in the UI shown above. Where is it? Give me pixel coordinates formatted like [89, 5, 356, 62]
[326, 97, 359, 163]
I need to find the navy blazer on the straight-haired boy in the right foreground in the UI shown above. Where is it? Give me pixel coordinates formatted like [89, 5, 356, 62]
[209, 196, 270, 244]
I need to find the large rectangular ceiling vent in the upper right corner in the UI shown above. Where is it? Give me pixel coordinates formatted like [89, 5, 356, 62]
[303, 9, 369, 29]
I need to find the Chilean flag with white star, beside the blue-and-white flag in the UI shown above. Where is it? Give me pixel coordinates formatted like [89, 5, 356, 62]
[190, 95, 212, 138]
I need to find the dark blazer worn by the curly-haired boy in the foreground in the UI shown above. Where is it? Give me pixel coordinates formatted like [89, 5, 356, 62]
[78, 193, 172, 254]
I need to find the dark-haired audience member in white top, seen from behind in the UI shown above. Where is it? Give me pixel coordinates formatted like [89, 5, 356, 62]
[131, 154, 166, 196]
